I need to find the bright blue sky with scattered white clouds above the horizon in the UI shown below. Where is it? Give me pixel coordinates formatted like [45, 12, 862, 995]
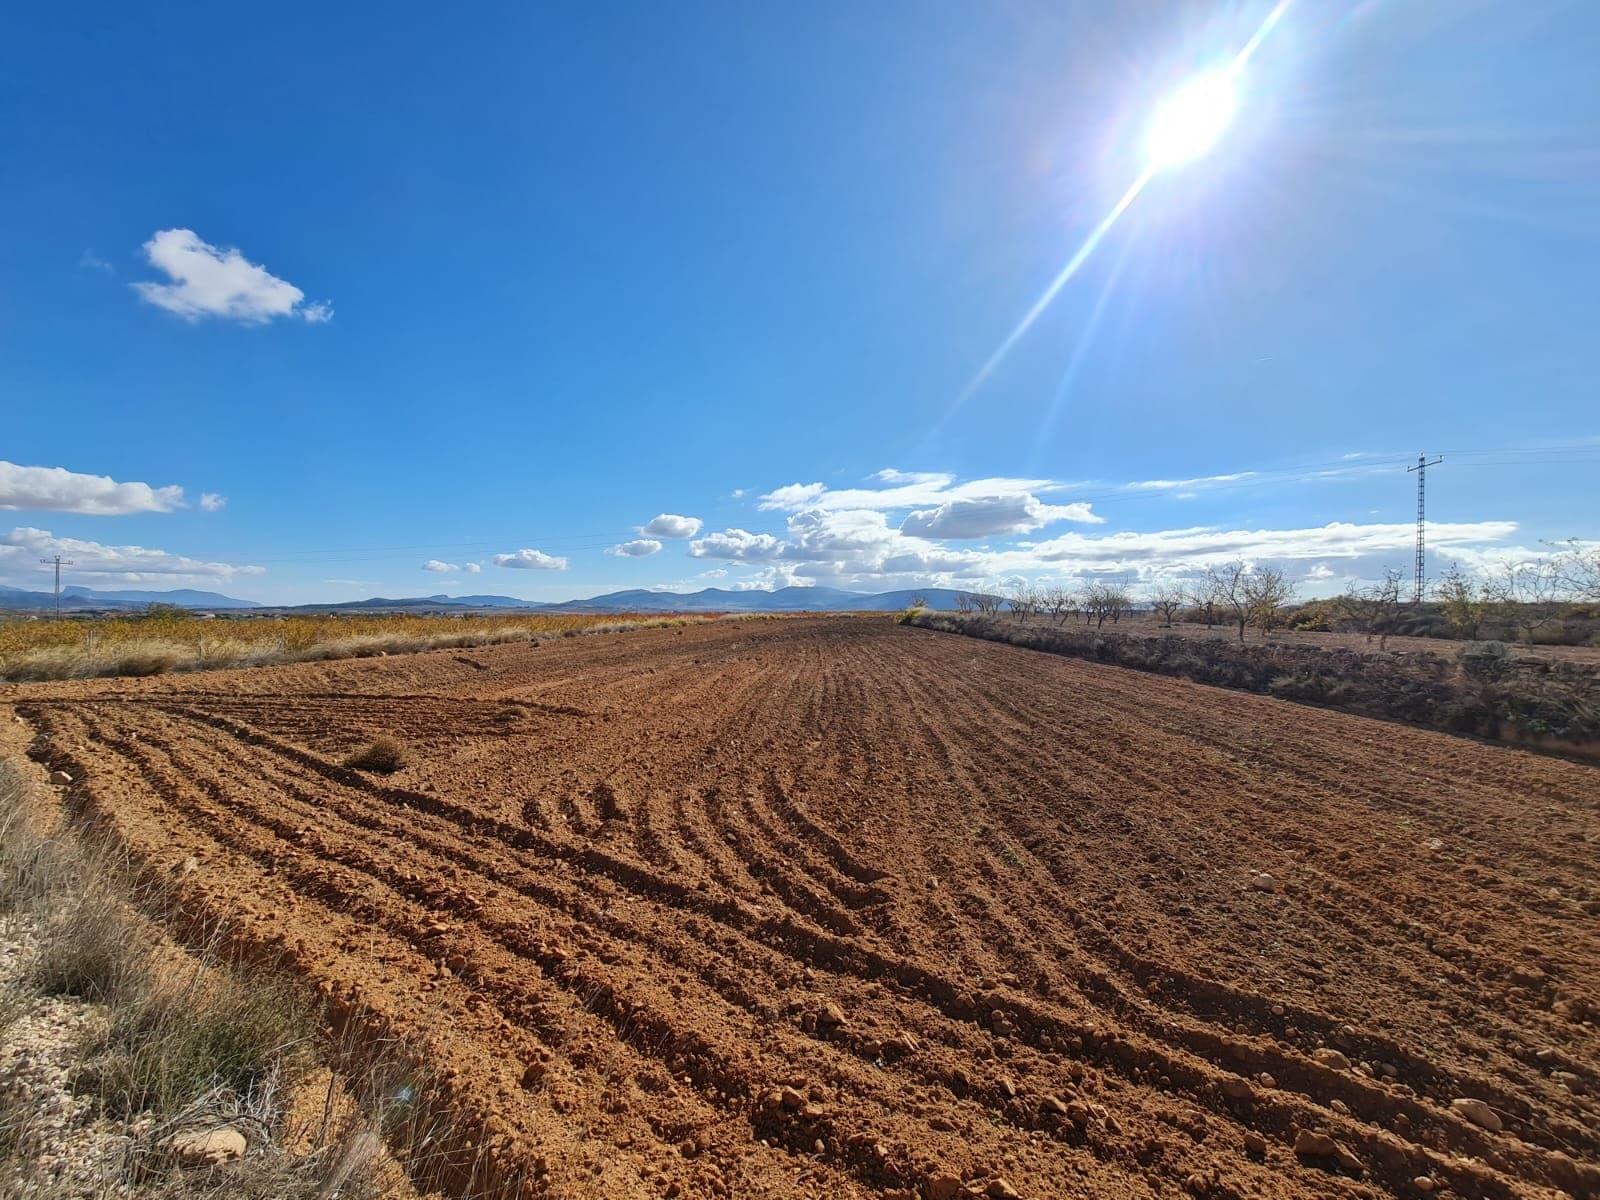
[0, 0, 1600, 602]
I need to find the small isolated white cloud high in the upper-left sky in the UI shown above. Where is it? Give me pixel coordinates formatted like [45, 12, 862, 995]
[133, 229, 333, 325]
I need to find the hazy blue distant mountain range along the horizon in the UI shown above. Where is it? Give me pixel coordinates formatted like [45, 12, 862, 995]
[0, 586, 979, 613]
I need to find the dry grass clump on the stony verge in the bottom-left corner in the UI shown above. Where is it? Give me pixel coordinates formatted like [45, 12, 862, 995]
[0, 762, 419, 1200]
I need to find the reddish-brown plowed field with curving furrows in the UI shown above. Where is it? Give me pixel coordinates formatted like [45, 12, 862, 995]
[0, 618, 1600, 1200]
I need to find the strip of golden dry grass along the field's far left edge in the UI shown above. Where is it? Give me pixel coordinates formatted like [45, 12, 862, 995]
[0, 613, 732, 682]
